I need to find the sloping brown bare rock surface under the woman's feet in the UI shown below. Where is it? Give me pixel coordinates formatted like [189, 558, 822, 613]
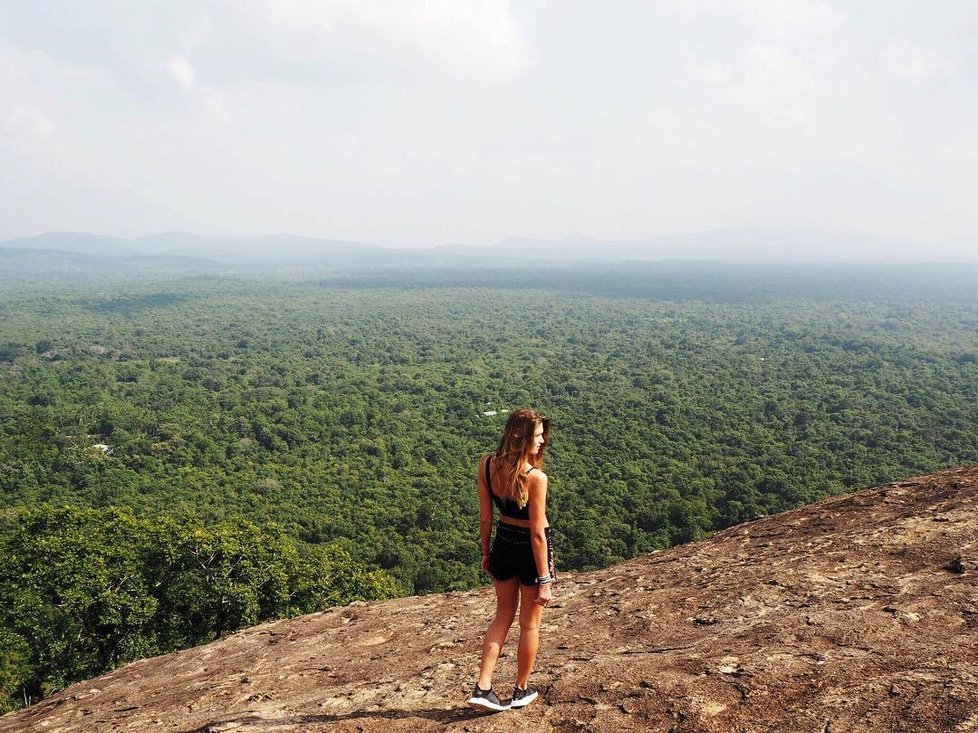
[0, 468, 978, 733]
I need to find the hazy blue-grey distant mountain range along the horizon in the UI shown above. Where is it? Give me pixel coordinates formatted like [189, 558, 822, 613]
[0, 227, 978, 266]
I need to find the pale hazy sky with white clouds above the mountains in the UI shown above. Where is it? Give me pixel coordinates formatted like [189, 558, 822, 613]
[0, 0, 978, 245]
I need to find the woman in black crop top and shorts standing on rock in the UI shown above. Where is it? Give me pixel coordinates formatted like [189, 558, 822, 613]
[468, 409, 555, 711]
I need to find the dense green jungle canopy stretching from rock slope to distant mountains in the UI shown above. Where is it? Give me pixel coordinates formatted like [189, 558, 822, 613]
[0, 262, 978, 709]
